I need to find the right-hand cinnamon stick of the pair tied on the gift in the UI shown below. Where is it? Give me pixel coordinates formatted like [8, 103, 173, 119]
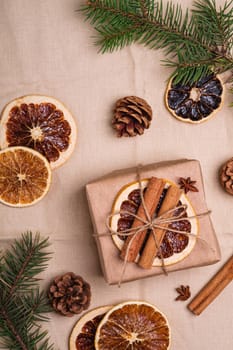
[138, 185, 182, 269]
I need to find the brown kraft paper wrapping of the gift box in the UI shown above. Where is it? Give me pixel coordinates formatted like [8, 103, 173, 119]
[86, 159, 221, 284]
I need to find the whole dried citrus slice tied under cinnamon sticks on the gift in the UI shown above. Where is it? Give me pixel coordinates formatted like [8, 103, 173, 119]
[110, 179, 199, 266]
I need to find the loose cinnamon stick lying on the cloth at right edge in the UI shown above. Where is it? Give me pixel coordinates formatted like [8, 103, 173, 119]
[188, 255, 233, 315]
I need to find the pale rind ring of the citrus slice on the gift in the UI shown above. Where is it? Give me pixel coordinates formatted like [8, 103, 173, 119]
[109, 179, 199, 266]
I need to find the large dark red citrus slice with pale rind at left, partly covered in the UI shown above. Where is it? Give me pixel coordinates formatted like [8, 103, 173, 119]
[0, 95, 77, 169]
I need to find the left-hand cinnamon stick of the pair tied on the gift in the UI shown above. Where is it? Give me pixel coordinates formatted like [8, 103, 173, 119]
[121, 177, 165, 262]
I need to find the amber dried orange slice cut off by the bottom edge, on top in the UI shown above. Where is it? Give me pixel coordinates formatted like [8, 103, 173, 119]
[95, 301, 170, 350]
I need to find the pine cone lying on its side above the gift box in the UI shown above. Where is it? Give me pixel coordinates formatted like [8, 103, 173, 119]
[112, 96, 152, 137]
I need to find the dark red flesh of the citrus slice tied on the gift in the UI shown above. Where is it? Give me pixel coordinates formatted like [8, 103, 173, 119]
[117, 189, 191, 259]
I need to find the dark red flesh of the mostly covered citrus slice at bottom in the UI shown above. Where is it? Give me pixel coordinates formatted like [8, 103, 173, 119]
[75, 314, 105, 350]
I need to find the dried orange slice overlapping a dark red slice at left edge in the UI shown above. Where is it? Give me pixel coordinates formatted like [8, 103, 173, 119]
[0, 147, 51, 207]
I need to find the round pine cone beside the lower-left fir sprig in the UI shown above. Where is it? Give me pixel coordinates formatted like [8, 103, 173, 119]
[48, 272, 91, 316]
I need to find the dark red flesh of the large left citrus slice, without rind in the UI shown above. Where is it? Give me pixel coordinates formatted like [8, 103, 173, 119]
[6, 102, 71, 162]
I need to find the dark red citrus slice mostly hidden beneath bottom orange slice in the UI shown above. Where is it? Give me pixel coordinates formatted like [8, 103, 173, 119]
[69, 306, 112, 350]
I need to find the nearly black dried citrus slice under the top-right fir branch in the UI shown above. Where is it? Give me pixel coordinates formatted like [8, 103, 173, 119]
[165, 74, 224, 123]
